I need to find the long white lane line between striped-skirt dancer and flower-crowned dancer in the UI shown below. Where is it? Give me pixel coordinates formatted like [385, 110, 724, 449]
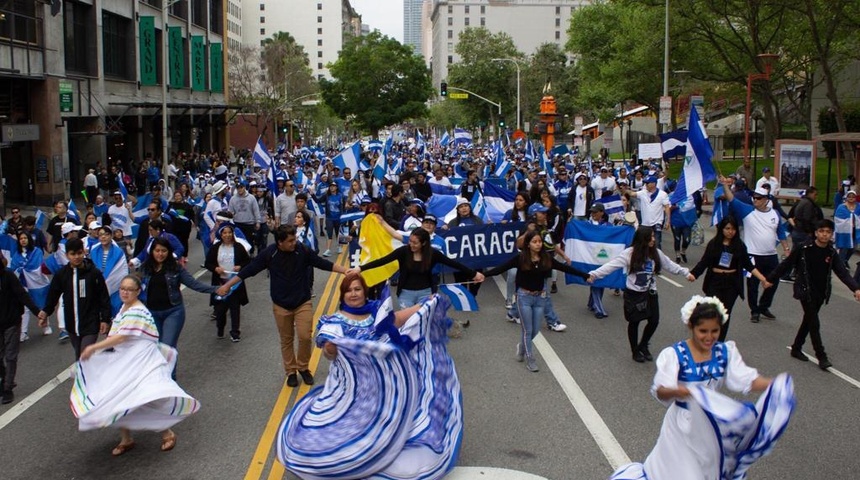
[493, 276, 628, 468]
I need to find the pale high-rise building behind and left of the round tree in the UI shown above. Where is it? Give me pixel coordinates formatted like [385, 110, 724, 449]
[242, 0, 361, 78]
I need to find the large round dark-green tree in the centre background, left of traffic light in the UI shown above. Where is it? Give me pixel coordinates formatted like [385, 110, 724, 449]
[320, 31, 433, 137]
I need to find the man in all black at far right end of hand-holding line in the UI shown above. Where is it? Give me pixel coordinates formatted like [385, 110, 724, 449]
[767, 219, 860, 370]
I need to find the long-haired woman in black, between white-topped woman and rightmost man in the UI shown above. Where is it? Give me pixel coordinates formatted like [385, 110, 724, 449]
[690, 215, 771, 342]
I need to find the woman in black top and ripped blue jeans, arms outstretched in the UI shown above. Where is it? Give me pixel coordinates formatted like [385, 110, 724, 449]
[485, 230, 588, 372]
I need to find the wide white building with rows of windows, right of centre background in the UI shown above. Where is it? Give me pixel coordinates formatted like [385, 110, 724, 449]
[430, 0, 593, 89]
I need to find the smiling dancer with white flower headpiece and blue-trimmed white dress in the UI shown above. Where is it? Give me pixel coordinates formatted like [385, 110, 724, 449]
[611, 295, 795, 480]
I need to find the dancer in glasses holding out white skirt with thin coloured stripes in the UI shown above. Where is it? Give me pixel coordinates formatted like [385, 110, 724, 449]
[75, 275, 200, 456]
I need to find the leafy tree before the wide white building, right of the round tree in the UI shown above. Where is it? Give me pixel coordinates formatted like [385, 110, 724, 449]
[448, 27, 525, 124]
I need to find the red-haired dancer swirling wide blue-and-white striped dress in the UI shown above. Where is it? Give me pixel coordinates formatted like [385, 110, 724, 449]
[277, 273, 463, 479]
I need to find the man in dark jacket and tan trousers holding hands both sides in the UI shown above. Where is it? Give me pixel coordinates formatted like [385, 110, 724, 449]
[217, 225, 346, 387]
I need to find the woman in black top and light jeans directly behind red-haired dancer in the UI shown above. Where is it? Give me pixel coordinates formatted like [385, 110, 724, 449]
[347, 228, 484, 308]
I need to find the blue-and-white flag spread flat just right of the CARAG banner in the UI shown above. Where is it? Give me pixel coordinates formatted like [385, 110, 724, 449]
[564, 222, 634, 288]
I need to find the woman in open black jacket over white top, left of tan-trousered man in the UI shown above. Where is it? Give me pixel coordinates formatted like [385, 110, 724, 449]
[205, 223, 251, 343]
